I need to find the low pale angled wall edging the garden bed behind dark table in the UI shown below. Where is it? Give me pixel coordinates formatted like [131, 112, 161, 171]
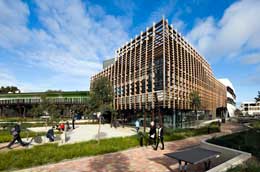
[200, 140, 252, 172]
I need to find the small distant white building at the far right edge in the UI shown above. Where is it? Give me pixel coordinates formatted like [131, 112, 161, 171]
[240, 101, 260, 115]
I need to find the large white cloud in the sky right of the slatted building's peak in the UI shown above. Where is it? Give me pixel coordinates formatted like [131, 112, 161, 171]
[187, 0, 260, 60]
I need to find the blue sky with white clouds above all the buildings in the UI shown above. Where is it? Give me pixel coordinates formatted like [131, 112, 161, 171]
[0, 0, 260, 105]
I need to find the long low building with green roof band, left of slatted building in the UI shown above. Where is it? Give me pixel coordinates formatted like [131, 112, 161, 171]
[0, 91, 89, 116]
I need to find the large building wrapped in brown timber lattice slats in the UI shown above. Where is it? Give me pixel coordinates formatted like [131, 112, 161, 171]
[90, 19, 226, 127]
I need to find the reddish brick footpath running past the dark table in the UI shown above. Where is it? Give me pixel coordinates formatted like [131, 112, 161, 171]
[16, 123, 242, 172]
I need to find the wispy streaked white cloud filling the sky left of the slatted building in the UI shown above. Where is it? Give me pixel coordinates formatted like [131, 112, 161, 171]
[0, 0, 128, 89]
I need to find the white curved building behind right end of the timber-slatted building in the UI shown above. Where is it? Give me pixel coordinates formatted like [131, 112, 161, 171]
[218, 78, 237, 118]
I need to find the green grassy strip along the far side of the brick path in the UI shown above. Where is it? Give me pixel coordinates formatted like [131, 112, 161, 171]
[0, 125, 219, 170]
